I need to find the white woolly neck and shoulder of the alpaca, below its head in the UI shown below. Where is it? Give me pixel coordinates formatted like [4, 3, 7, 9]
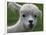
[8, 19, 25, 32]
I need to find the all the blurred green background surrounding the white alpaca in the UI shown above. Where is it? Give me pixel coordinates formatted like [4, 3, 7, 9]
[7, 2, 43, 31]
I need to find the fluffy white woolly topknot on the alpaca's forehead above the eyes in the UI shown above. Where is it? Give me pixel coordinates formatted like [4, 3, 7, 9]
[20, 4, 40, 15]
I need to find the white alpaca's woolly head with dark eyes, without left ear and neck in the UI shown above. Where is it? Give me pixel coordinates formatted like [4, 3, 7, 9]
[20, 4, 40, 29]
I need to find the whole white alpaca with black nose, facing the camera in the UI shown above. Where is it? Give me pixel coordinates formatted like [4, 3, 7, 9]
[7, 3, 41, 33]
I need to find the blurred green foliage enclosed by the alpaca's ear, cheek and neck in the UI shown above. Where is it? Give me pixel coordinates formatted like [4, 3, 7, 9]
[7, 2, 19, 26]
